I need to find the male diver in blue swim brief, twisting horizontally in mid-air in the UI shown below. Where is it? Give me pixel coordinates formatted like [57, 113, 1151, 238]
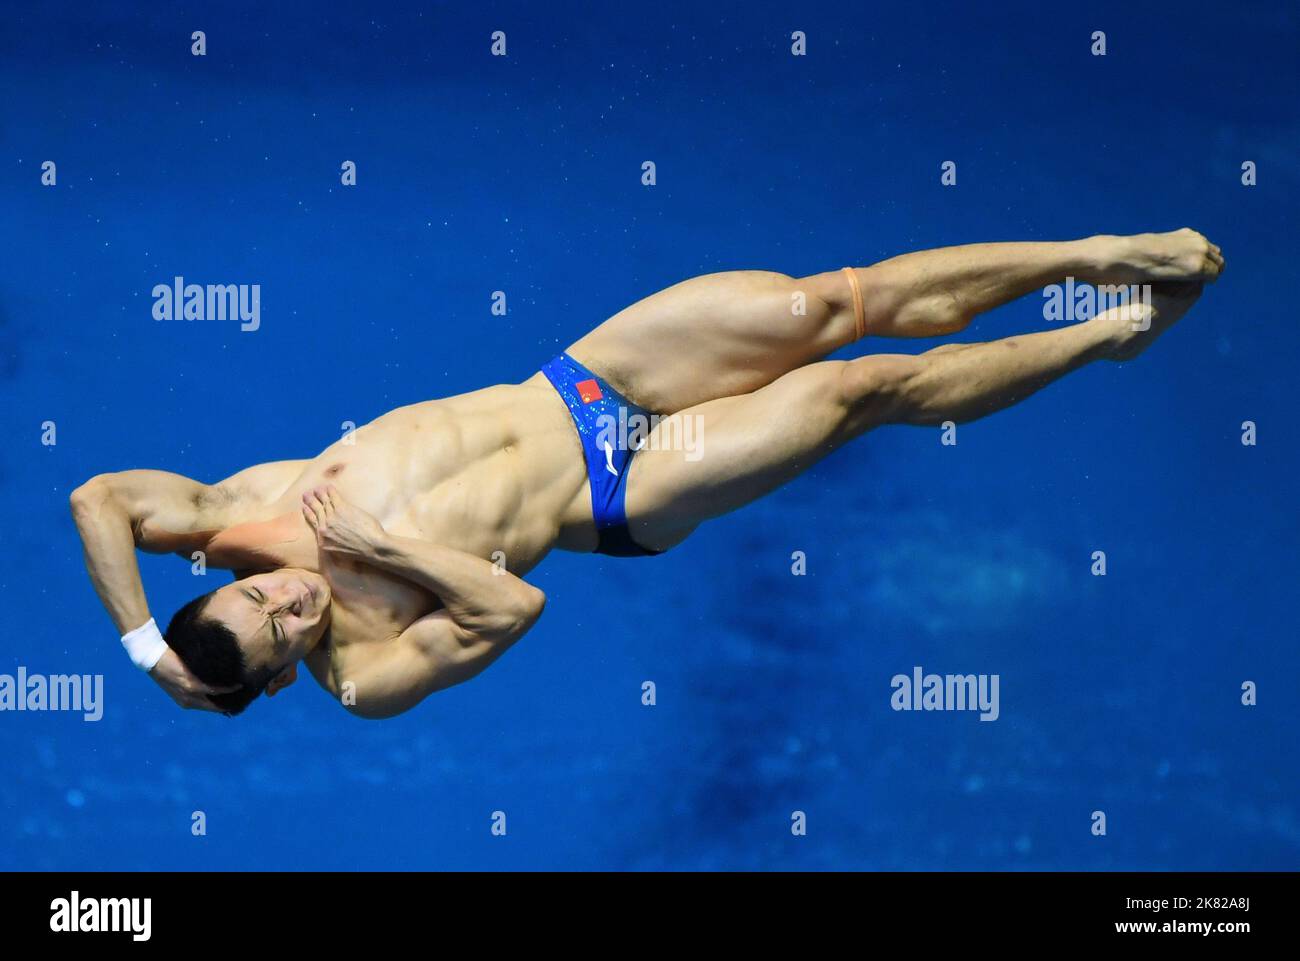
[72, 228, 1223, 718]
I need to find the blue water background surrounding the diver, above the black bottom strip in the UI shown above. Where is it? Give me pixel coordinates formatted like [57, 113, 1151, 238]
[0, 3, 1300, 870]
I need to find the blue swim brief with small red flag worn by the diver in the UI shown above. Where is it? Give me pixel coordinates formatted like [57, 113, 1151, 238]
[542, 354, 663, 558]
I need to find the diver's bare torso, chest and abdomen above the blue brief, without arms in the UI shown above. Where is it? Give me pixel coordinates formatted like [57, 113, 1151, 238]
[209, 375, 595, 671]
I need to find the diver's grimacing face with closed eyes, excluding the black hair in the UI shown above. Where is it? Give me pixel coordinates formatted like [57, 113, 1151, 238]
[204, 567, 330, 671]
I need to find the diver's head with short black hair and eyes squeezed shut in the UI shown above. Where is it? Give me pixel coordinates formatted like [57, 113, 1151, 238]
[165, 567, 330, 715]
